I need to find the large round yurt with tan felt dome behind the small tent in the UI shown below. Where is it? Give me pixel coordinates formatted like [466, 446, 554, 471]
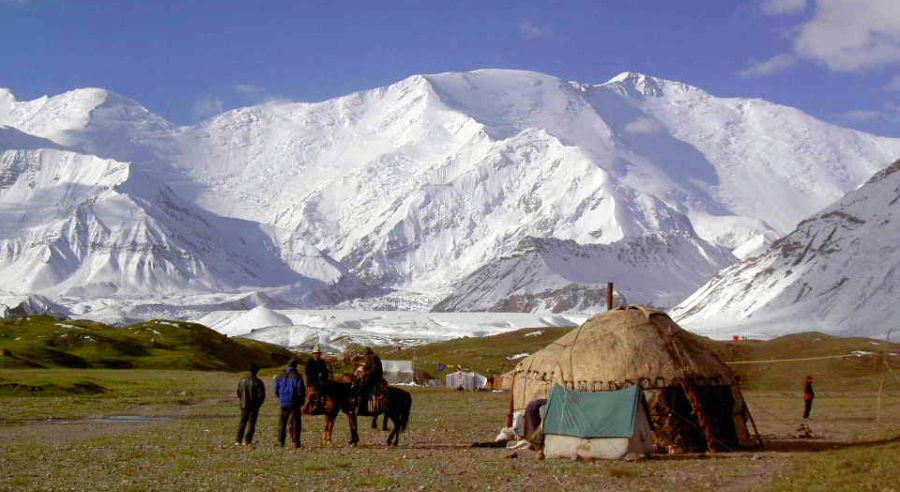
[511, 306, 759, 451]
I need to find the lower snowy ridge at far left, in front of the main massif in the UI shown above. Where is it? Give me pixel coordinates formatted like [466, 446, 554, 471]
[0, 149, 336, 297]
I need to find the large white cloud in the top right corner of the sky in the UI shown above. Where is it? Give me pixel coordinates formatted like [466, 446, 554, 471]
[794, 0, 900, 72]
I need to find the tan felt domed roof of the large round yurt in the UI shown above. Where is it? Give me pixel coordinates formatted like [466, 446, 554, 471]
[512, 306, 734, 409]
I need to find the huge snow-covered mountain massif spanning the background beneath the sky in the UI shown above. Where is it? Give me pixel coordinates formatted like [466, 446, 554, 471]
[0, 70, 900, 326]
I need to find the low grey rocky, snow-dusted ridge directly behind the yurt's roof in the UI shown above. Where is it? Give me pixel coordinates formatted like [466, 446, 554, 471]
[435, 233, 736, 312]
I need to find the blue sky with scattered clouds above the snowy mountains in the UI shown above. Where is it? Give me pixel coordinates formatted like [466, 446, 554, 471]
[0, 0, 900, 136]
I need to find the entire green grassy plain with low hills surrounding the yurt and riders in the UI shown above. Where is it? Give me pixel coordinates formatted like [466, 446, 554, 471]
[0, 319, 900, 491]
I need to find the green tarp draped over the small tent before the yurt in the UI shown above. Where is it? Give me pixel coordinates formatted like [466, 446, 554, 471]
[544, 384, 641, 438]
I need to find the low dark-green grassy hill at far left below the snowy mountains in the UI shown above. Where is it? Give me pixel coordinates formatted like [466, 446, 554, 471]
[0, 316, 291, 371]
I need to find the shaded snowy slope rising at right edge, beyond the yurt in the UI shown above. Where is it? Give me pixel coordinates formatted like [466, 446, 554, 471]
[674, 161, 900, 336]
